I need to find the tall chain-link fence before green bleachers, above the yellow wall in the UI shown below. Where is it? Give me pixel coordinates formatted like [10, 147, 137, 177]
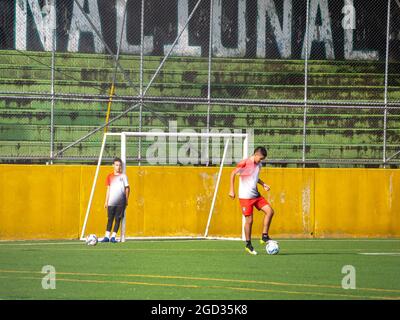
[0, 0, 400, 167]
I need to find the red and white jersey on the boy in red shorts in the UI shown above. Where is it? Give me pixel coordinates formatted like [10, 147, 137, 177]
[236, 158, 262, 199]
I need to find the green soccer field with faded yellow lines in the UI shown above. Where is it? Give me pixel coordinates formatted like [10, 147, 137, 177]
[0, 239, 400, 300]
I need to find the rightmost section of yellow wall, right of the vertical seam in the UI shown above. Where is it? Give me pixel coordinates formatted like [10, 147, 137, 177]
[314, 169, 400, 237]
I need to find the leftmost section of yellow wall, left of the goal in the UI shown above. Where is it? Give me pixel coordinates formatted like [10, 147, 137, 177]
[0, 165, 81, 239]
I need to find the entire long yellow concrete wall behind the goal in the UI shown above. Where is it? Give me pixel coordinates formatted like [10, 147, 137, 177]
[0, 165, 400, 240]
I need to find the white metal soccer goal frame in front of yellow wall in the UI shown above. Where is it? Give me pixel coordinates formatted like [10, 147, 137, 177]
[80, 132, 249, 242]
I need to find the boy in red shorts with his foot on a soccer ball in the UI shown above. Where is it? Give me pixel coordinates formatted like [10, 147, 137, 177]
[229, 147, 274, 255]
